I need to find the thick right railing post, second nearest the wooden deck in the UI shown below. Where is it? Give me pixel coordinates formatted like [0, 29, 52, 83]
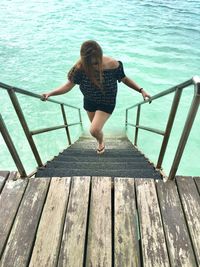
[156, 88, 183, 169]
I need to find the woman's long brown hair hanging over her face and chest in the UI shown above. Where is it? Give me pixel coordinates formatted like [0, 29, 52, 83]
[68, 40, 103, 89]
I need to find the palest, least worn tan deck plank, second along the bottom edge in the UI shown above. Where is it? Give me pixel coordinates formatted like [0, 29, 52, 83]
[29, 177, 71, 267]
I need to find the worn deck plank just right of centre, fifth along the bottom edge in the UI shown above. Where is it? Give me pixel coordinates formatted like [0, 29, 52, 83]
[114, 178, 141, 267]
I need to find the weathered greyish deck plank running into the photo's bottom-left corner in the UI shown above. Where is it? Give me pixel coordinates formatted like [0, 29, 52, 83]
[0, 178, 50, 267]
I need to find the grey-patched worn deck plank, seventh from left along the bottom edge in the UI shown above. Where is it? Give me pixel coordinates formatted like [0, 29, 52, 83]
[157, 181, 197, 267]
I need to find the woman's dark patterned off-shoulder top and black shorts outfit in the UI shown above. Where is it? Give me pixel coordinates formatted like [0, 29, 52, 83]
[71, 61, 125, 114]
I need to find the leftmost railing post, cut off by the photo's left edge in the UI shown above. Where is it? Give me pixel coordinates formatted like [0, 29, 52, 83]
[0, 114, 27, 177]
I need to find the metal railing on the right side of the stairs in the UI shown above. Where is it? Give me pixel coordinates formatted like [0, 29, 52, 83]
[125, 76, 200, 180]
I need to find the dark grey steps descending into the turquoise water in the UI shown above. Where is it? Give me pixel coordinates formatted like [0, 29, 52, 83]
[35, 136, 162, 179]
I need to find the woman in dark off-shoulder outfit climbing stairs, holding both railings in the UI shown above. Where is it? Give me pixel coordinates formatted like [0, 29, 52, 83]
[42, 40, 150, 154]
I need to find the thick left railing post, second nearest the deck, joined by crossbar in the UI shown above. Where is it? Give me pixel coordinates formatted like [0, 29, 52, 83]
[8, 89, 43, 166]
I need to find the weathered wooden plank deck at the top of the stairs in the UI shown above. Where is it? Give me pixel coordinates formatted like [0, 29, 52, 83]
[0, 172, 200, 267]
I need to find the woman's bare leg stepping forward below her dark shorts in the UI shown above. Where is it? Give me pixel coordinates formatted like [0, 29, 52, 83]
[90, 110, 111, 152]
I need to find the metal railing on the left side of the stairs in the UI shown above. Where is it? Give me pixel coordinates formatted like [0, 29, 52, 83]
[0, 83, 82, 177]
